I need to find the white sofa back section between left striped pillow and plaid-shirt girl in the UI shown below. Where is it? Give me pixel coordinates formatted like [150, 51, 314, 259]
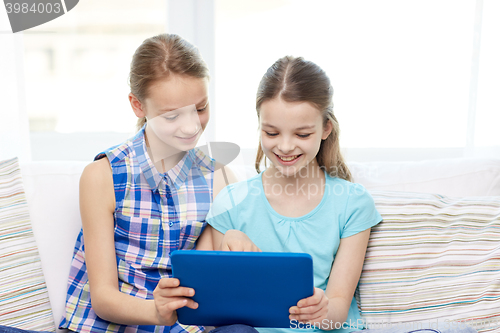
[21, 161, 89, 332]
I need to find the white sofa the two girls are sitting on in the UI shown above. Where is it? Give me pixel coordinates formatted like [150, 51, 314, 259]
[5, 158, 500, 332]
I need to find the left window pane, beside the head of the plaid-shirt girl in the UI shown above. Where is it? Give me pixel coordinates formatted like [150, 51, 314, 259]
[24, 0, 167, 160]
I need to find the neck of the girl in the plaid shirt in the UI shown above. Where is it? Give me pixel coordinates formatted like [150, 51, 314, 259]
[144, 126, 186, 173]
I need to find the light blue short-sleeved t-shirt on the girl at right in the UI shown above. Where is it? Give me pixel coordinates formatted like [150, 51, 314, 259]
[207, 173, 382, 333]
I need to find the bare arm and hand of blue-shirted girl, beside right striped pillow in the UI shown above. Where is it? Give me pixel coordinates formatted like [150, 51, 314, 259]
[290, 229, 370, 330]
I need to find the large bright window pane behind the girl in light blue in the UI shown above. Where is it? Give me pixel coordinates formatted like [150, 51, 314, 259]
[215, 0, 480, 152]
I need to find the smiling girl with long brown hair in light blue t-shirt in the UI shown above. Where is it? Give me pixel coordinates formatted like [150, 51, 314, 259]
[207, 57, 382, 332]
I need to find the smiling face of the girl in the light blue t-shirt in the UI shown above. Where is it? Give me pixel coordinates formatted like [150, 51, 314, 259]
[259, 98, 332, 177]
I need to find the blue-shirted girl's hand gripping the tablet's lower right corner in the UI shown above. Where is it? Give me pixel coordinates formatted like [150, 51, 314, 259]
[289, 288, 329, 324]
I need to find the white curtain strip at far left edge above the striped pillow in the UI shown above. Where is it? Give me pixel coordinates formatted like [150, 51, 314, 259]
[0, 9, 31, 162]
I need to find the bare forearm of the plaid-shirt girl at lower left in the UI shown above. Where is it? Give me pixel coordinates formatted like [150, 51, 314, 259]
[92, 287, 163, 325]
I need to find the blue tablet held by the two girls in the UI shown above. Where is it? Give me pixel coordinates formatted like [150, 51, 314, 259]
[171, 250, 314, 328]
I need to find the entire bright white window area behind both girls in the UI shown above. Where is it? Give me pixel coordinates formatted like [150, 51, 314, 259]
[16, 0, 500, 160]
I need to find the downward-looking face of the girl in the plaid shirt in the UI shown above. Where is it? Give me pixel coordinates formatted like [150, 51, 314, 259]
[136, 75, 210, 161]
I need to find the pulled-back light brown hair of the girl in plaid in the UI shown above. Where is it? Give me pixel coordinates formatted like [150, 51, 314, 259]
[129, 34, 209, 130]
